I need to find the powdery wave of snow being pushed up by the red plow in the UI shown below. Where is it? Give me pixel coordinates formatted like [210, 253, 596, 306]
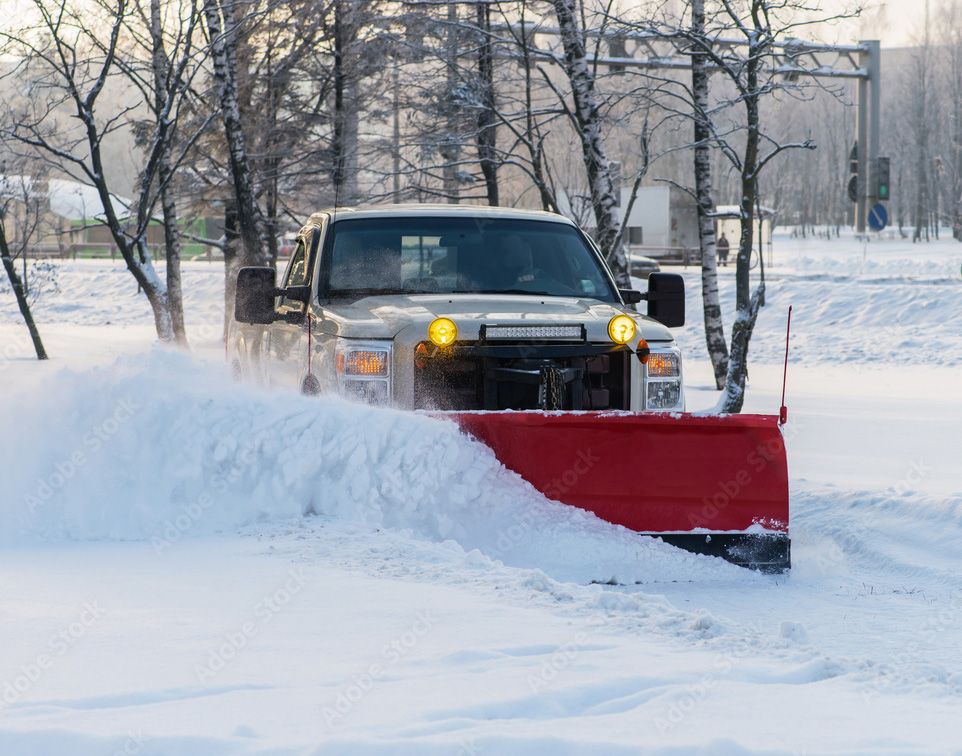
[0, 349, 736, 581]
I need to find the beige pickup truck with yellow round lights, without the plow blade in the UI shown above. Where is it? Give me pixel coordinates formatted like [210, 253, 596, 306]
[228, 205, 685, 412]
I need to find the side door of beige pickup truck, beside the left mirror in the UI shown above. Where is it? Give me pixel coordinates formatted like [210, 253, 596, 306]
[269, 229, 318, 389]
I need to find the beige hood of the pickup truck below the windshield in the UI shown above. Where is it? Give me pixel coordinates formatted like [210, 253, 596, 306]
[319, 294, 673, 341]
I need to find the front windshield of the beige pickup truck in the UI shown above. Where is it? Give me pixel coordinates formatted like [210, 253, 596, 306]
[322, 217, 618, 302]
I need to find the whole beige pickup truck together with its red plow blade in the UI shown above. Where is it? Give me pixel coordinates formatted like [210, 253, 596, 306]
[227, 205, 790, 571]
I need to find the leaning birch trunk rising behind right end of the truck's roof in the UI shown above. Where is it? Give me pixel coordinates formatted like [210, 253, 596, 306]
[552, 0, 631, 289]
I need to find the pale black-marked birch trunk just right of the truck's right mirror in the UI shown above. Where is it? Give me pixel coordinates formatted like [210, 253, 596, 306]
[691, 0, 728, 389]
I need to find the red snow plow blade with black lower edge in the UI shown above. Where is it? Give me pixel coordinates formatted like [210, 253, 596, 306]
[445, 412, 790, 572]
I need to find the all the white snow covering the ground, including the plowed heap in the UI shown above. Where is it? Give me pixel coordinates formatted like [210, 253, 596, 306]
[0, 239, 962, 755]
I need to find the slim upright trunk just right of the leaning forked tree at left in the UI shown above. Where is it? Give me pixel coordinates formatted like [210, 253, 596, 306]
[150, 0, 187, 346]
